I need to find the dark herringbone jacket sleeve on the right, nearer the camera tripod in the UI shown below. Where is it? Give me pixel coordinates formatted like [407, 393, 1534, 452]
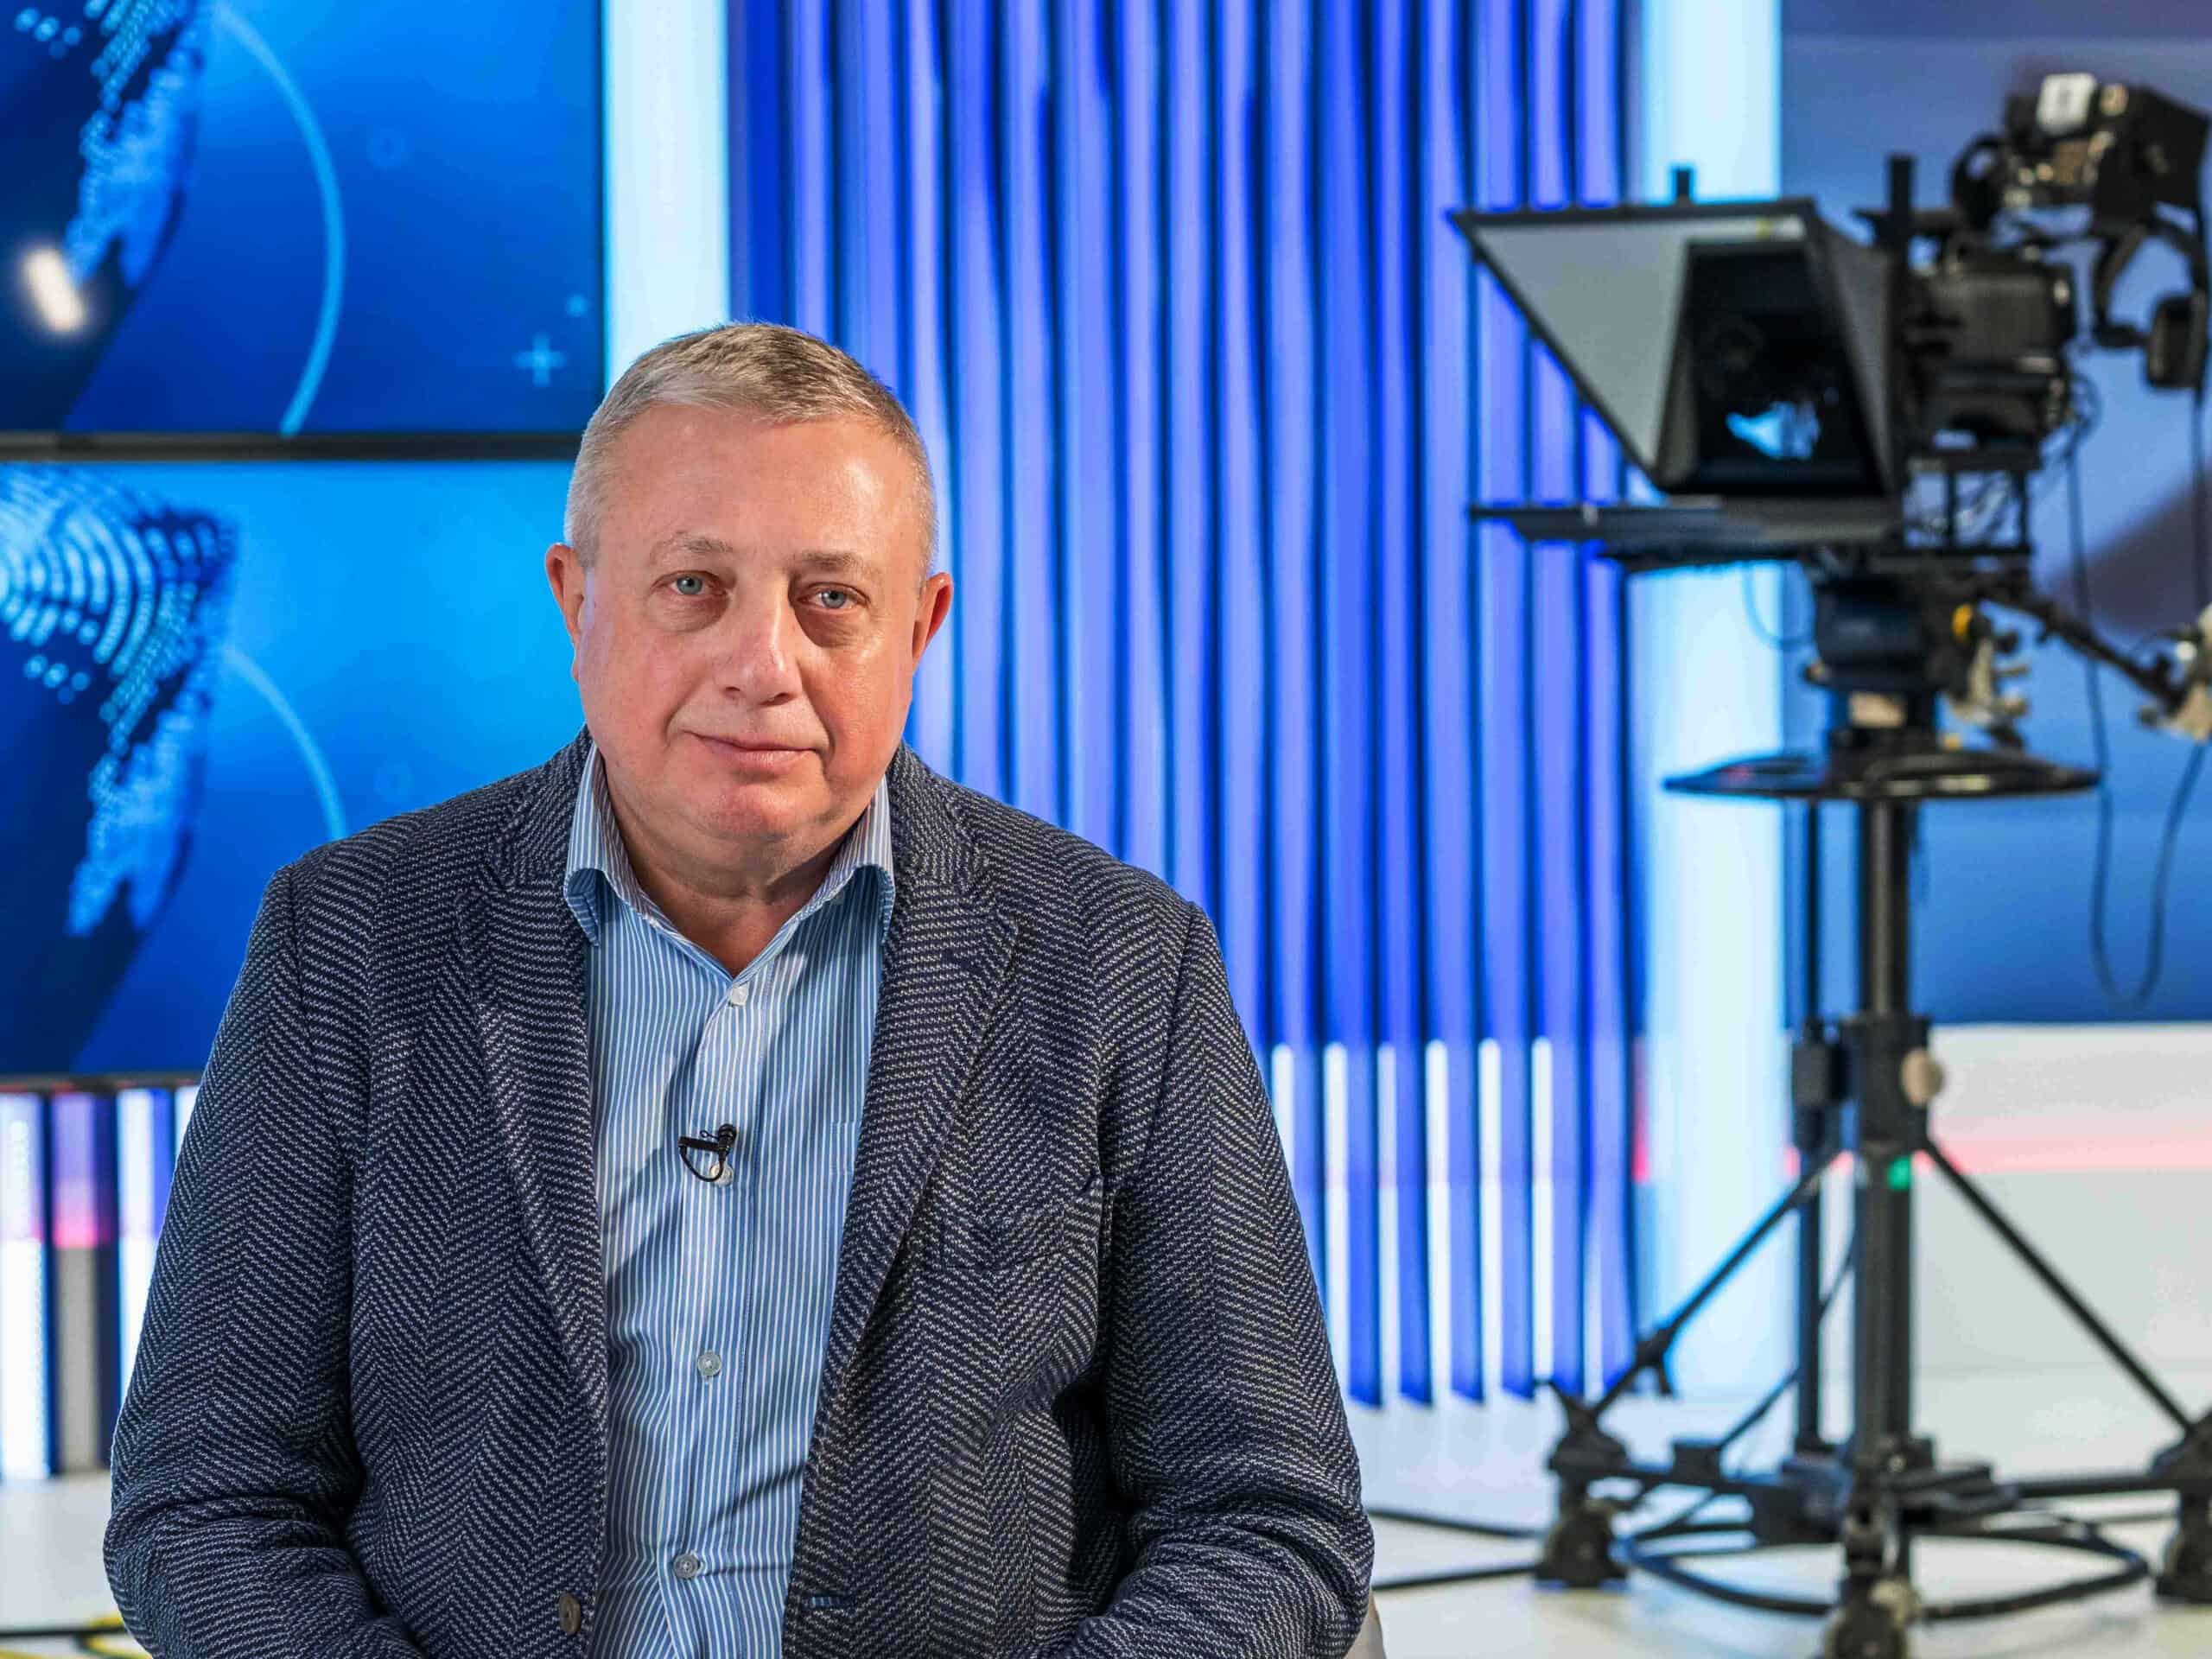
[1064, 907, 1374, 1659]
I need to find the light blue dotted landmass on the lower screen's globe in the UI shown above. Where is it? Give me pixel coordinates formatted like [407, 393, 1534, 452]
[0, 467, 237, 936]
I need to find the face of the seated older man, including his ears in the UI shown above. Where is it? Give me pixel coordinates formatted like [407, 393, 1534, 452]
[546, 407, 951, 868]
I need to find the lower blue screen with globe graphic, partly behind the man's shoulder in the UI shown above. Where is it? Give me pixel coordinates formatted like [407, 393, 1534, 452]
[0, 462, 582, 1075]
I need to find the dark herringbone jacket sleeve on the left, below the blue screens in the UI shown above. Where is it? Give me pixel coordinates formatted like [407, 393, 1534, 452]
[104, 865, 423, 1659]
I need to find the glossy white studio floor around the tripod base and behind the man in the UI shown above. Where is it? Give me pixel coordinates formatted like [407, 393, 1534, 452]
[0, 1367, 2212, 1659]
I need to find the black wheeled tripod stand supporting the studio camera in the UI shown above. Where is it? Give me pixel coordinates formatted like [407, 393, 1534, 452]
[1537, 584, 2212, 1659]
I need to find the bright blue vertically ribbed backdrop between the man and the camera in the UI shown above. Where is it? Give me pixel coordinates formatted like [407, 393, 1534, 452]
[730, 0, 1635, 1402]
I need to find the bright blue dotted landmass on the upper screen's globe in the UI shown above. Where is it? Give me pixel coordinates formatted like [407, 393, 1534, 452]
[11, 0, 213, 288]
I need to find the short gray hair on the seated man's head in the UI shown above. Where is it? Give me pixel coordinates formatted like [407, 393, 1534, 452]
[562, 323, 938, 575]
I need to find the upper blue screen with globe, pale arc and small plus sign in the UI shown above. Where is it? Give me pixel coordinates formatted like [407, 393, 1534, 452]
[0, 0, 604, 438]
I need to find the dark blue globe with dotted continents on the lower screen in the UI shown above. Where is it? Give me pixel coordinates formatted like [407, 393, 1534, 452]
[0, 467, 237, 1073]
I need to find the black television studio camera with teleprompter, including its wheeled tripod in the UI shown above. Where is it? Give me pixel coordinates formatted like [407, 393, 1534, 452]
[1451, 75, 2212, 1659]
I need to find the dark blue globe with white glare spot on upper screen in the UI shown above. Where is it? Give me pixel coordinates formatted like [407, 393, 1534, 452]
[0, 0, 213, 431]
